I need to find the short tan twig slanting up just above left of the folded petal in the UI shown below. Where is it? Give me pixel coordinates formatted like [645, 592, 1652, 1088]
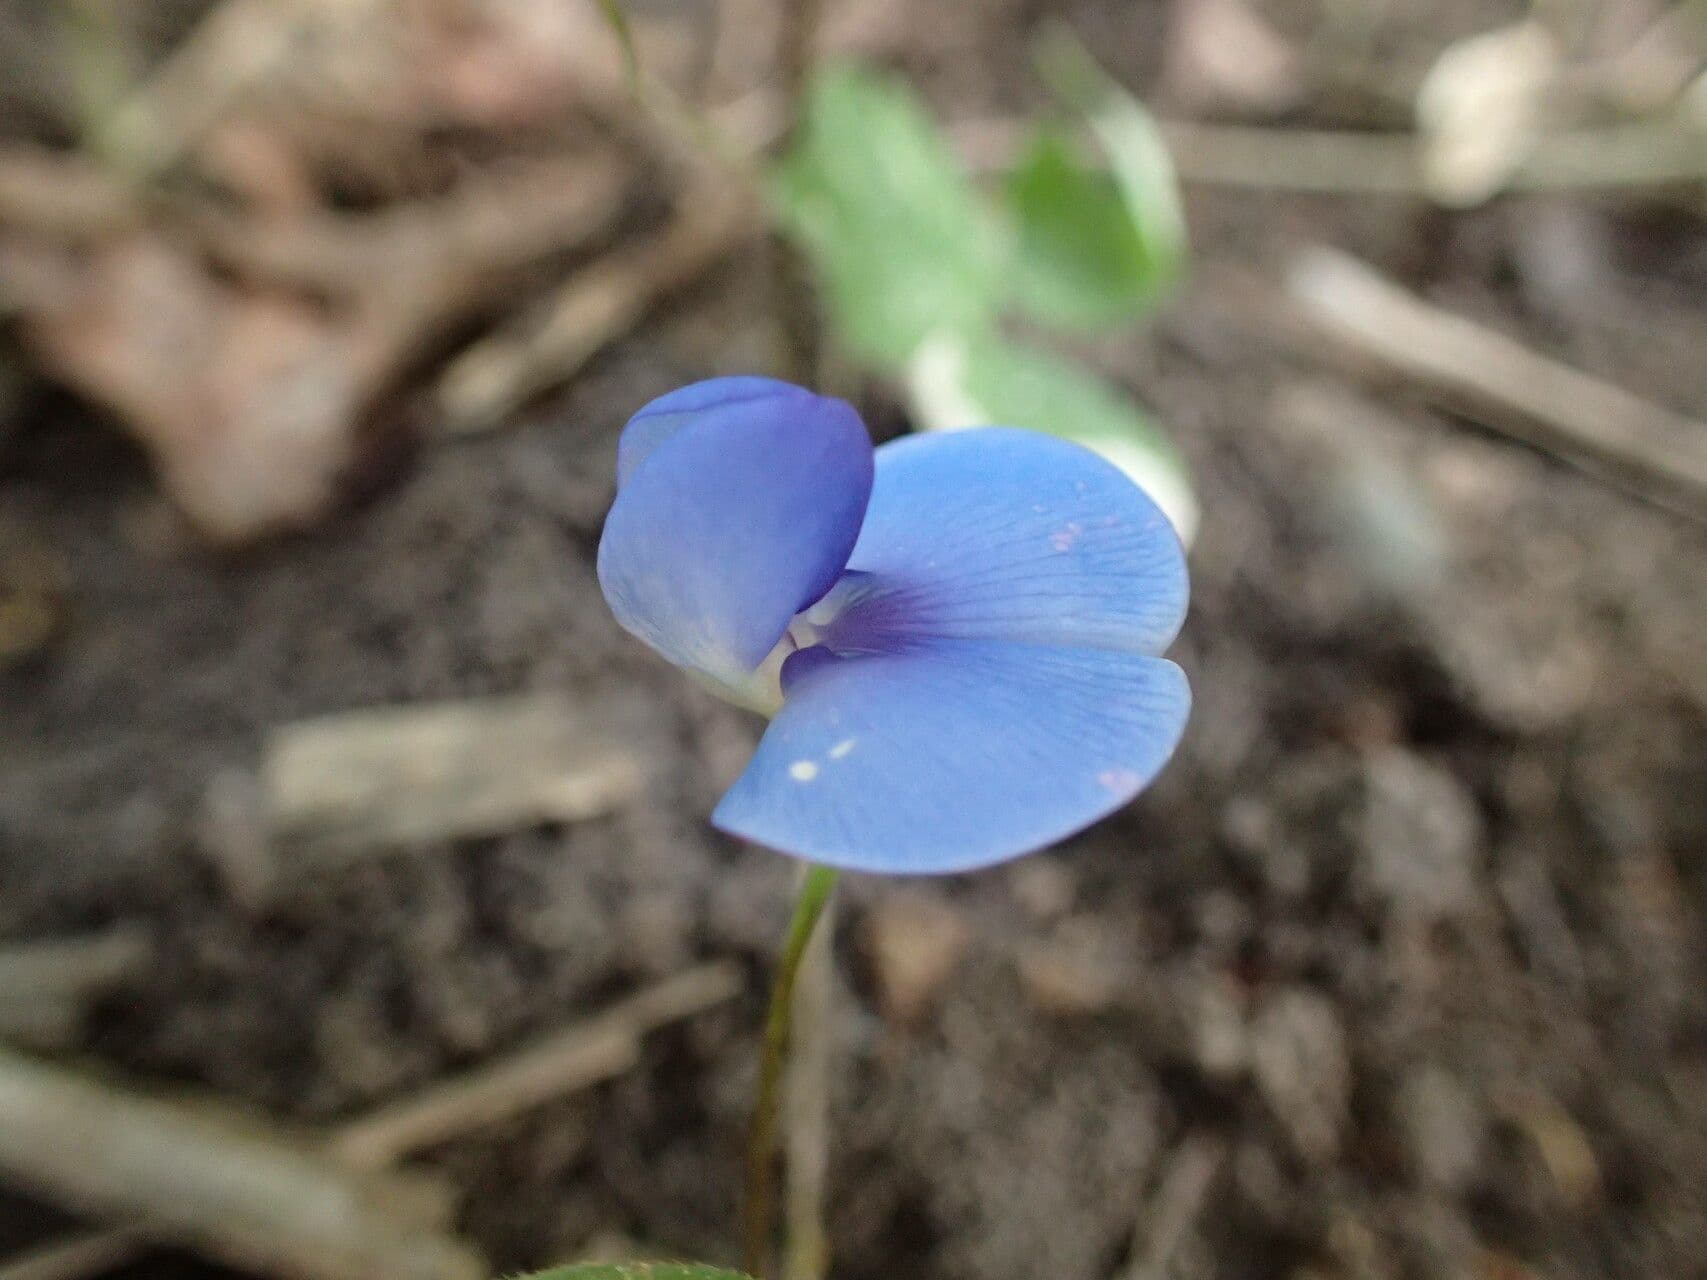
[439, 189, 756, 435]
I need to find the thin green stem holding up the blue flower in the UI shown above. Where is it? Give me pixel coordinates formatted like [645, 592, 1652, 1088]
[741, 865, 836, 1277]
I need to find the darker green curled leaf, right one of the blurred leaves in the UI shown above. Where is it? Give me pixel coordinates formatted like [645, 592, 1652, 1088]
[1005, 31, 1188, 328]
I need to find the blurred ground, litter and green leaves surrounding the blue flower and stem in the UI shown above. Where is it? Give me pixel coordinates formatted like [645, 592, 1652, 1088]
[0, 0, 1707, 1280]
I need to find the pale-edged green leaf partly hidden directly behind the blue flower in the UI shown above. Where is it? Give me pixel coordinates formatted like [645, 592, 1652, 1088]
[906, 331, 1198, 544]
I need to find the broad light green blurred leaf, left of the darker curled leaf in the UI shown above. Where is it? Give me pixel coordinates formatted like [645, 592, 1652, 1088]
[773, 67, 1005, 369]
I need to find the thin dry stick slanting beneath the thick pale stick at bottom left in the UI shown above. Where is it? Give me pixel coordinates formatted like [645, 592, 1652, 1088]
[0, 963, 741, 1280]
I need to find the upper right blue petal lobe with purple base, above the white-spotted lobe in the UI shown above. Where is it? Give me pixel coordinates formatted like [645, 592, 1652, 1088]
[823, 427, 1188, 655]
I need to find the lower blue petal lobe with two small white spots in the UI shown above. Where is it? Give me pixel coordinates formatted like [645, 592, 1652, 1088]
[712, 640, 1191, 874]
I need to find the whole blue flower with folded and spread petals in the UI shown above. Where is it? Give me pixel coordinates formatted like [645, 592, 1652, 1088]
[599, 377, 1191, 874]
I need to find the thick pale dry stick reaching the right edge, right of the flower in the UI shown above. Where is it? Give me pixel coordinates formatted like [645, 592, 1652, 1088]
[1285, 247, 1707, 519]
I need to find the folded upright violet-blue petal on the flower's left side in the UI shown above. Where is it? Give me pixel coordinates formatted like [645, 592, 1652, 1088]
[599, 377, 872, 679]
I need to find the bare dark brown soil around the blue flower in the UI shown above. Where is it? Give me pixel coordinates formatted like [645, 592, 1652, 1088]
[0, 3, 1707, 1280]
